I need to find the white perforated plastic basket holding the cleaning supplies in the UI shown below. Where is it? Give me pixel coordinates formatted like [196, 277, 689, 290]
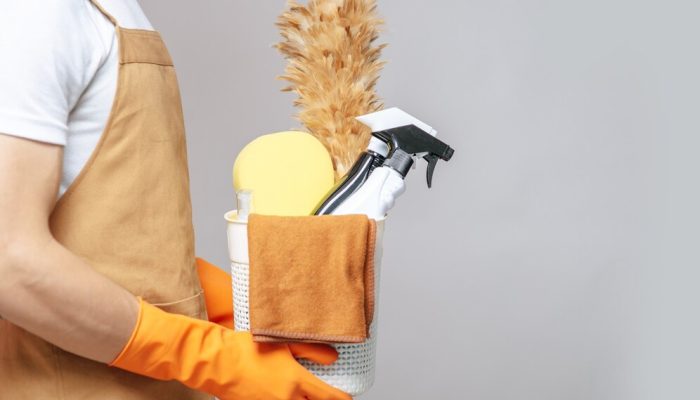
[224, 210, 384, 396]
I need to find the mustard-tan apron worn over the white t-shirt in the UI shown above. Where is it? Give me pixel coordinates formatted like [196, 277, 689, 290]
[0, 1, 210, 400]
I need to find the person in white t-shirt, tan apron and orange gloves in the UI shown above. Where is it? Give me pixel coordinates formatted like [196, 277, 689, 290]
[0, 0, 350, 400]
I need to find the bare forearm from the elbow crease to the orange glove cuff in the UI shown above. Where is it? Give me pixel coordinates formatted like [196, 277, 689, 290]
[0, 235, 138, 363]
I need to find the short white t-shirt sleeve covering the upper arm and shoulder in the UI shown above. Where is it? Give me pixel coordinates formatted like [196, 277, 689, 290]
[0, 0, 102, 145]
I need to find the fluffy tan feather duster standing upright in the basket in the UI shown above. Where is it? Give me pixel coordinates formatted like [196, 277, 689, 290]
[276, 0, 385, 179]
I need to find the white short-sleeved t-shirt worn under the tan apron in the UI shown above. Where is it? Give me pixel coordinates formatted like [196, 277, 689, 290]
[0, 0, 153, 197]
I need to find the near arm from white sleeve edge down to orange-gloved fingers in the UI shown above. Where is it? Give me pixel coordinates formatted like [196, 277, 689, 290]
[0, 134, 351, 400]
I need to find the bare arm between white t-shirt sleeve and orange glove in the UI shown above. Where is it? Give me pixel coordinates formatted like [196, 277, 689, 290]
[0, 134, 139, 363]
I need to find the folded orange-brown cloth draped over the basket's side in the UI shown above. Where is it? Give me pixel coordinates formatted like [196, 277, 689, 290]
[248, 214, 376, 343]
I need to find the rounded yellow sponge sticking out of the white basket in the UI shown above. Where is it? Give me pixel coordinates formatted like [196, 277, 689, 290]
[233, 131, 335, 215]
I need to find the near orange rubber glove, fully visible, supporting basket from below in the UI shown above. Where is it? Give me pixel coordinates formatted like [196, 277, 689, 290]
[110, 300, 352, 400]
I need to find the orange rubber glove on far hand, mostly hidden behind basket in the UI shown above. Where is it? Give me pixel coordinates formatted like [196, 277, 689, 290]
[197, 258, 233, 329]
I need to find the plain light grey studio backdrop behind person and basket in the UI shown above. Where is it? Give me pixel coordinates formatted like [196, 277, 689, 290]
[141, 0, 700, 400]
